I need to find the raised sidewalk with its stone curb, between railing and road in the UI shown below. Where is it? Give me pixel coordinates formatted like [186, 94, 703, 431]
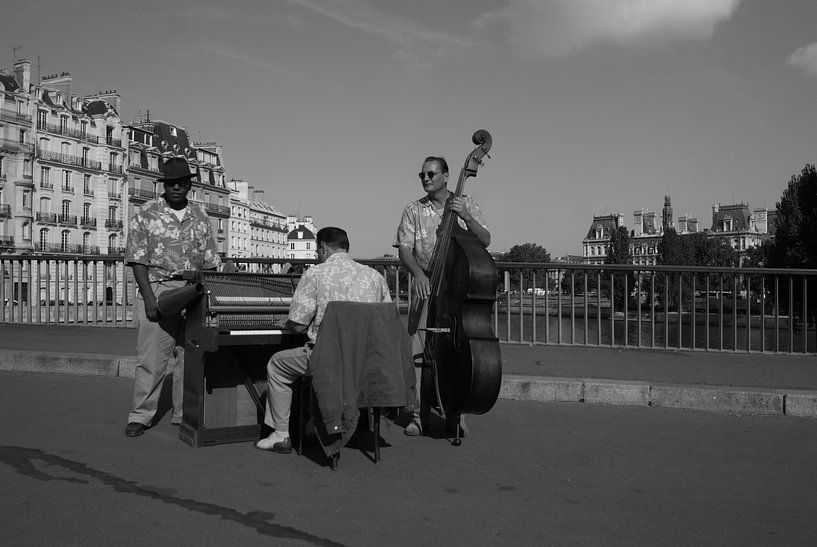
[0, 324, 817, 418]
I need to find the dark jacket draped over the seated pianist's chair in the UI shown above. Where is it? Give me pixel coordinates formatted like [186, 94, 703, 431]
[307, 301, 417, 457]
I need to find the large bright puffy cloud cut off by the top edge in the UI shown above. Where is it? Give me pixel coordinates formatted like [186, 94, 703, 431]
[475, 0, 741, 57]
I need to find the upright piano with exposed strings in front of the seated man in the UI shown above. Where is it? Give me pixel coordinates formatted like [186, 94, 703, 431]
[179, 271, 307, 446]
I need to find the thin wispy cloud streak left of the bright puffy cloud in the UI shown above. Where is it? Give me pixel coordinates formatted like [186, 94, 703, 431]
[286, 0, 475, 64]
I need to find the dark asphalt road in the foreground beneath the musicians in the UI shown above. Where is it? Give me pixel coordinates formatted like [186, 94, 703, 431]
[0, 373, 817, 545]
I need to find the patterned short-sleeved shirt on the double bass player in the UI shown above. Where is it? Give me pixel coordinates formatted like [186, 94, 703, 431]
[392, 196, 488, 270]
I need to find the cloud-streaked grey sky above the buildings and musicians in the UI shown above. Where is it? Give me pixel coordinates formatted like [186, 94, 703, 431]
[0, 0, 817, 258]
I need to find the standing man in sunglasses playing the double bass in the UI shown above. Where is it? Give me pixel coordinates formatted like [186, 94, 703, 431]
[394, 156, 491, 436]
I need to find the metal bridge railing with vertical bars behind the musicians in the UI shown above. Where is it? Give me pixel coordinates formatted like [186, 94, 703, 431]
[0, 255, 817, 354]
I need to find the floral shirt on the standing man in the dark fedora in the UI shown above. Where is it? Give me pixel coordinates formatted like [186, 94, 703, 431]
[125, 197, 221, 281]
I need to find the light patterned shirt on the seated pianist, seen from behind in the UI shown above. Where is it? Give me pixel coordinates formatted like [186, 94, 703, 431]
[289, 252, 391, 344]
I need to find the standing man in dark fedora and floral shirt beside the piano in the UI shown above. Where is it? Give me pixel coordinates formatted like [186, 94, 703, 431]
[125, 157, 220, 437]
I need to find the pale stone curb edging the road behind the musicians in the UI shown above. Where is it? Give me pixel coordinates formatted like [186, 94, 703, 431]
[0, 350, 817, 418]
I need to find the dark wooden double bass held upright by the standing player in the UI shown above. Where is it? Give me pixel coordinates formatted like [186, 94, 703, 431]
[420, 129, 502, 446]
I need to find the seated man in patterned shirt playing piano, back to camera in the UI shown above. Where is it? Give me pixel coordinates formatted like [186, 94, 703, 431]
[255, 227, 391, 454]
